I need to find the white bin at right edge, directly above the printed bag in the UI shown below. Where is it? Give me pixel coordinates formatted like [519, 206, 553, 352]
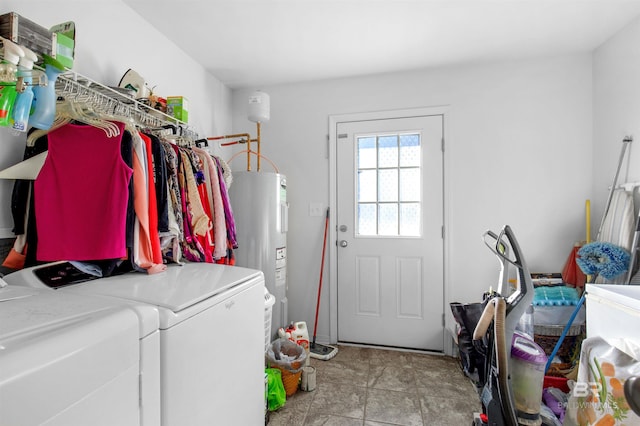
[586, 284, 640, 346]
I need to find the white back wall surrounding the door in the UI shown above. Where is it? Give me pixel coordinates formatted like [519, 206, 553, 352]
[233, 54, 592, 341]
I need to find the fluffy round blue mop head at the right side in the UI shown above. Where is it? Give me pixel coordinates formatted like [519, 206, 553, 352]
[576, 241, 631, 280]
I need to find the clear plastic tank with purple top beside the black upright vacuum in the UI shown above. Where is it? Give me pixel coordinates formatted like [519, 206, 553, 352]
[511, 331, 547, 426]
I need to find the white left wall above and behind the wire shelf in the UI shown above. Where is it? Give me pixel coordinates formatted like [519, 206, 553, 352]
[0, 0, 231, 237]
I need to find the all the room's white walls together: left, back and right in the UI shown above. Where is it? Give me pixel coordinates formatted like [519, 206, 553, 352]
[0, 0, 616, 350]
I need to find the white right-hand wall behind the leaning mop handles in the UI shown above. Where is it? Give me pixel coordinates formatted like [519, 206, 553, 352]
[591, 19, 640, 221]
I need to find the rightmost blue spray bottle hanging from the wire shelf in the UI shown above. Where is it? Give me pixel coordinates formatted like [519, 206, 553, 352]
[29, 55, 64, 130]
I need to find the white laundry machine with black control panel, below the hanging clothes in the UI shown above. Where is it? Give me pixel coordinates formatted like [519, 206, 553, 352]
[5, 262, 264, 426]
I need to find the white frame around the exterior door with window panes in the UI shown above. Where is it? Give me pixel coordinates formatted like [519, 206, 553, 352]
[327, 105, 452, 355]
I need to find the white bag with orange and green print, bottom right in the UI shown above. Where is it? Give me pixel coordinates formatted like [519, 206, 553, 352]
[563, 337, 640, 426]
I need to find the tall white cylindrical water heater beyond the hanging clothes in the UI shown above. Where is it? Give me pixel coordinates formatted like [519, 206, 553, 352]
[229, 171, 289, 340]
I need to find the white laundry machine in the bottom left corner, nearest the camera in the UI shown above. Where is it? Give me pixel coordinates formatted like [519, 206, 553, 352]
[0, 279, 159, 426]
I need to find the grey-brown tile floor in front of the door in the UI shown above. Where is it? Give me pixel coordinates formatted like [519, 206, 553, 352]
[268, 345, 480, 426]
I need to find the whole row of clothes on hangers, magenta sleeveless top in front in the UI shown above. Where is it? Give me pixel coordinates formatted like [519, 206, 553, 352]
[5, 105, 237, 276]
